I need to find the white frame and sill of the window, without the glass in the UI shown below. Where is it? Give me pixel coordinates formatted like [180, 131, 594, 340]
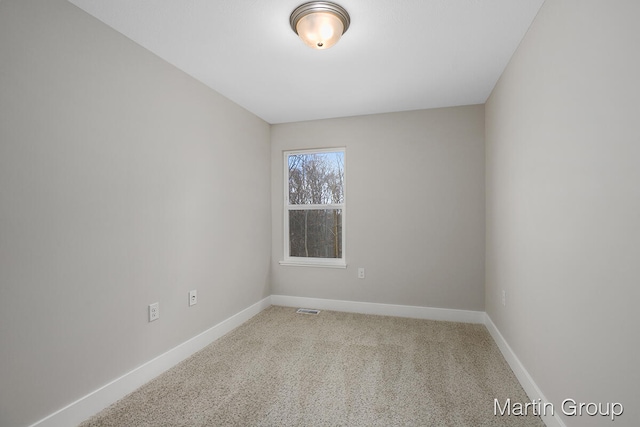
[280, 147, 347, 268]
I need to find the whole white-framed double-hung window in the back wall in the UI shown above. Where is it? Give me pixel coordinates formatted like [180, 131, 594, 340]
[281, 148, 346, 268]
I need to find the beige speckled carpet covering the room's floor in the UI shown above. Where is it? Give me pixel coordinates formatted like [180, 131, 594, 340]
[81, 307, 544, 427]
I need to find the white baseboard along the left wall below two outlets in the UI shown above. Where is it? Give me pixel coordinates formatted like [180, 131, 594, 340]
[31, 297, 271, 427]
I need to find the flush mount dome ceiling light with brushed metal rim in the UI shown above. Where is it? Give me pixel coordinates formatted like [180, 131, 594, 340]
[289, 1, 351, 49]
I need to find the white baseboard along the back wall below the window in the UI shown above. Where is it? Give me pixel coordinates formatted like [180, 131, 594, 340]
[271, 295, 485, 323]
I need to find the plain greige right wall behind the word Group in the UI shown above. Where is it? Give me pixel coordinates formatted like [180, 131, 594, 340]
[485, 0, 640, 426]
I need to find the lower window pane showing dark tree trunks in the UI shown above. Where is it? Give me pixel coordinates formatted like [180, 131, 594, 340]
[289, 209, 342, 258]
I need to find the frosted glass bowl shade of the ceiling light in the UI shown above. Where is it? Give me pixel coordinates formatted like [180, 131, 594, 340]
[296, 12, 344, 49]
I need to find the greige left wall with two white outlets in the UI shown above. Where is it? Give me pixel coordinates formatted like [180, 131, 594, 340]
[0, 0, 271, 426]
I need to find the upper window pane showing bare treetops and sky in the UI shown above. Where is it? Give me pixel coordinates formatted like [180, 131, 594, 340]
[288, 151, 344, 205]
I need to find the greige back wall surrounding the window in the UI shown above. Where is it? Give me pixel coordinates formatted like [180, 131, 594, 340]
[271, 105, 484, 311]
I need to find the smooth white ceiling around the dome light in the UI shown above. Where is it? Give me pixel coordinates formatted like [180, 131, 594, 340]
[69, 0, 544, 123]
